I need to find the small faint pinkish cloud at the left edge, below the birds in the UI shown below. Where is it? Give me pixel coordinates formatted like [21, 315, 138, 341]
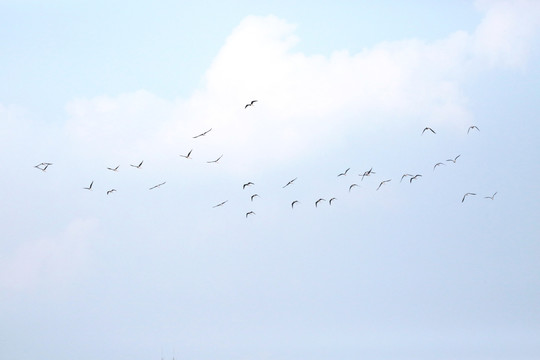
[0, 219, 97, 291]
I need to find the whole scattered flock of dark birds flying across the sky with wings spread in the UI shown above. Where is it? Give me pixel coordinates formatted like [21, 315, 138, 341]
[34, 100, 497, 218]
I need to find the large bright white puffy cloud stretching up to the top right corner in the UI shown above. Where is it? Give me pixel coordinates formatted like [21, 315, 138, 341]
[61, 1, 539, 173]
